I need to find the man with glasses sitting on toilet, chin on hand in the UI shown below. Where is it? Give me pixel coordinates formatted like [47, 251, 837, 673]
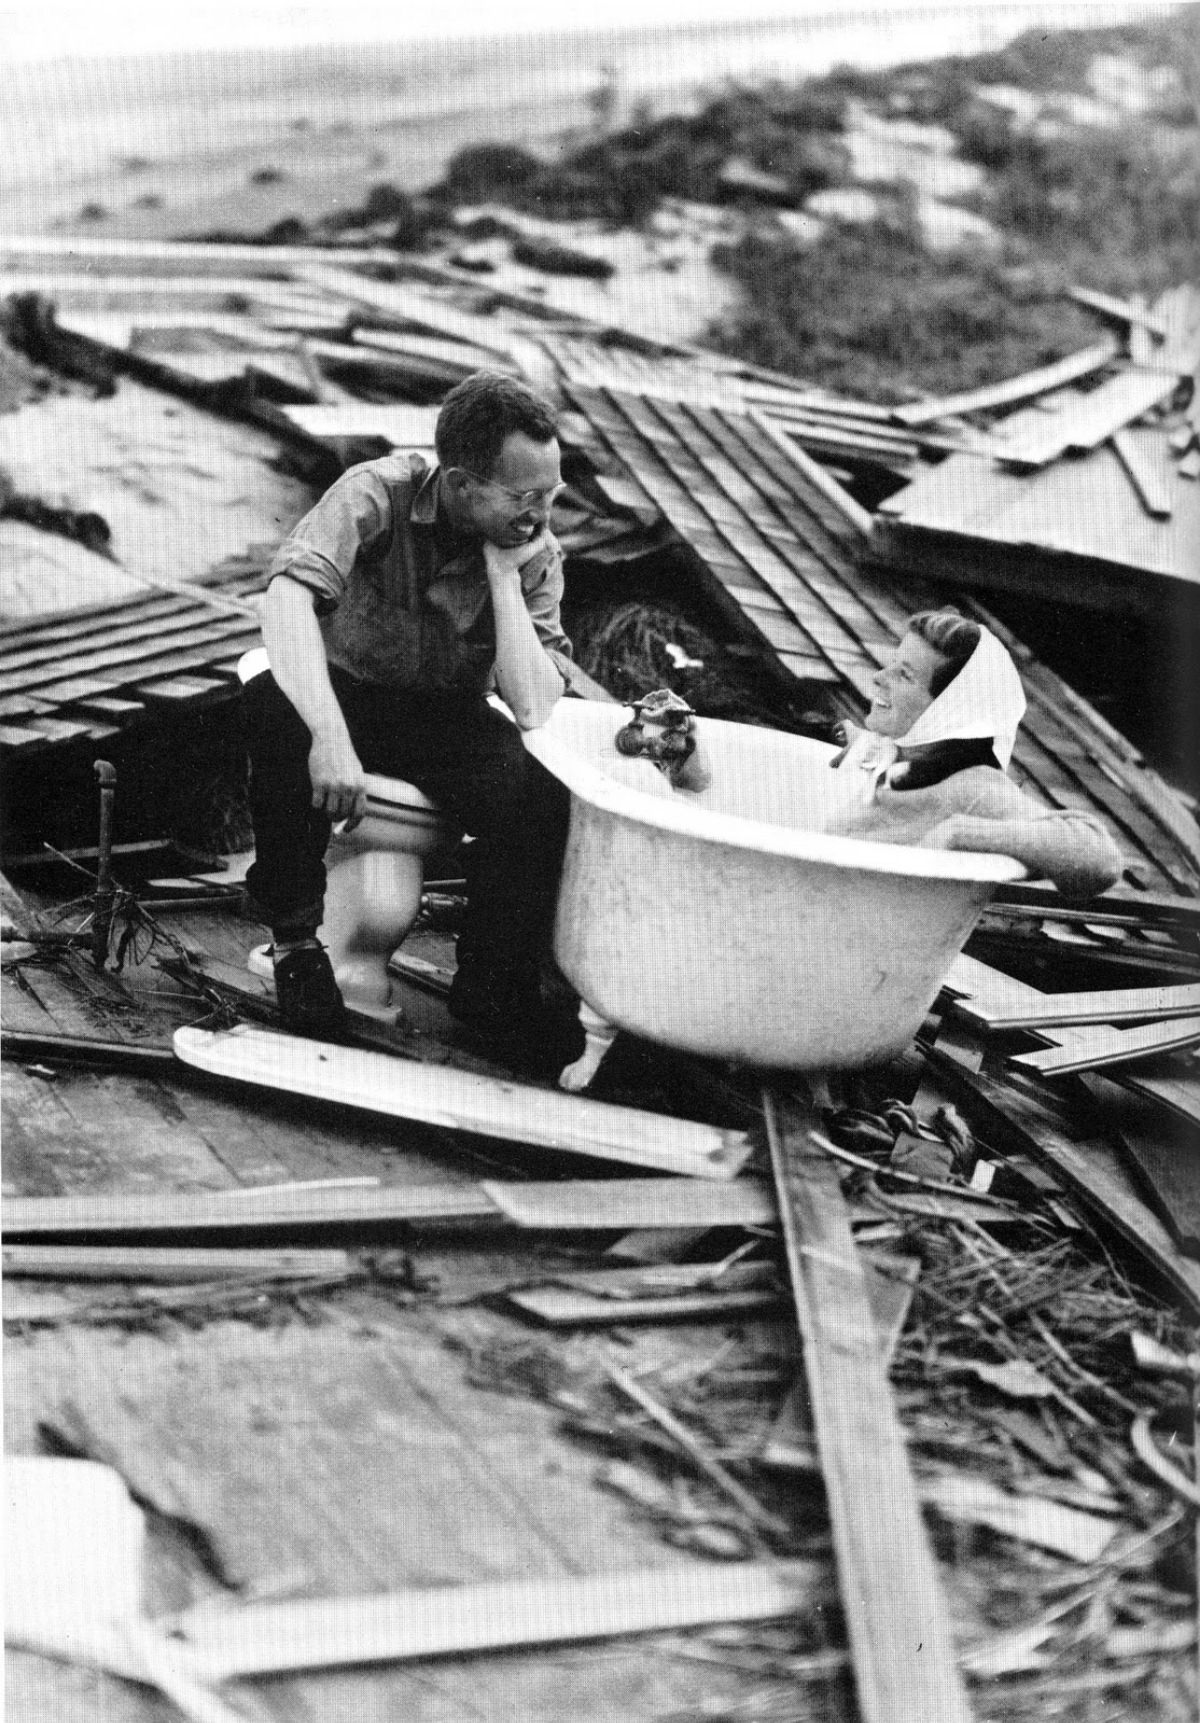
[247, 370, 583, 1070]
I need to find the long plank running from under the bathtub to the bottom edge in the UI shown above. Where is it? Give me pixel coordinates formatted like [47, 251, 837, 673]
[764, 1089, 971, 1723]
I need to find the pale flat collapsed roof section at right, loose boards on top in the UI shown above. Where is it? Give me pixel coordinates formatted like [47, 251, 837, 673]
[876, 286, 1200, 617]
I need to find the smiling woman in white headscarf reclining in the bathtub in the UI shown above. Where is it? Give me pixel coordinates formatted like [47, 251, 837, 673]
[826, 610, 1121, 898]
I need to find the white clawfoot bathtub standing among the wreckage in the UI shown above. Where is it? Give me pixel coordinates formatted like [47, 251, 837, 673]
[524, 700, 1026, 1089]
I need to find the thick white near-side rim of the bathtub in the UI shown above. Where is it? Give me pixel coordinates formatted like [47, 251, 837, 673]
[521, 708, 1031, 886]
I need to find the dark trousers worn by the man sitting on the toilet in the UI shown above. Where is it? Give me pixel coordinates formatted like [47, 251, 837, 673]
[245, 667, 569, 1015]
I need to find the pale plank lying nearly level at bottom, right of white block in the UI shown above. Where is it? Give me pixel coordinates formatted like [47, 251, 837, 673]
[176, 1561, 824, 1674]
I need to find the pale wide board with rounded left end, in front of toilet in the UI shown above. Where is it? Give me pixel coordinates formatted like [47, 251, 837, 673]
[174, 1023, 750, 1179]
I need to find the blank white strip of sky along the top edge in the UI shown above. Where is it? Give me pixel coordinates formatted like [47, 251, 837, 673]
[0, 0, 1128, 65]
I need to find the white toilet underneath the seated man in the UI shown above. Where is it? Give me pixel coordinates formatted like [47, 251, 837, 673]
[238, 648, 459, 1018]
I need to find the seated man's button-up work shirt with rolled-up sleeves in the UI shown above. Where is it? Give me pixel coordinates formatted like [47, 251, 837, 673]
[271, 455, 571, 694]
